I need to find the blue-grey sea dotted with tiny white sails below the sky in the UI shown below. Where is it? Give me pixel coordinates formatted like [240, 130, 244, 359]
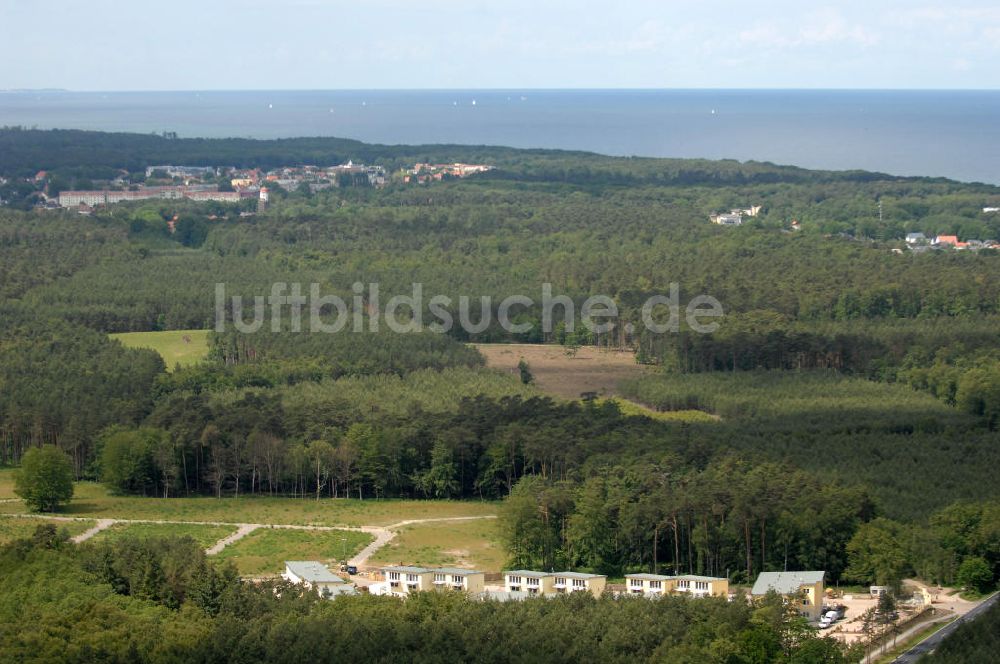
[0, 90, 1000, 184]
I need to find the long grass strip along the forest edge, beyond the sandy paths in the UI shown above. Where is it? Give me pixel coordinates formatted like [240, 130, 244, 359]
[0, 473, 498, 526]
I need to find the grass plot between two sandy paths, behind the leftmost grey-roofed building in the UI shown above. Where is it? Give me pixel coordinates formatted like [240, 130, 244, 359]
[216, 528, 373, 575]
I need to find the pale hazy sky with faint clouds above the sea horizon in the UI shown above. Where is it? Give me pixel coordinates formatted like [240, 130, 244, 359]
[0, 0, 1000, 90]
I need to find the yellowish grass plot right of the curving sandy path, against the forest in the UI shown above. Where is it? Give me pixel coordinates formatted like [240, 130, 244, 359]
[370, 519, 506, 572]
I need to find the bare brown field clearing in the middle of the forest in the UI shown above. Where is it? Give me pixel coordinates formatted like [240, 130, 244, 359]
[475, 344, 645, 399]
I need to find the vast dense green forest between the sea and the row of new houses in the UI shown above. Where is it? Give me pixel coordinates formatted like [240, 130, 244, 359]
[0, 130, 1000, 611]
